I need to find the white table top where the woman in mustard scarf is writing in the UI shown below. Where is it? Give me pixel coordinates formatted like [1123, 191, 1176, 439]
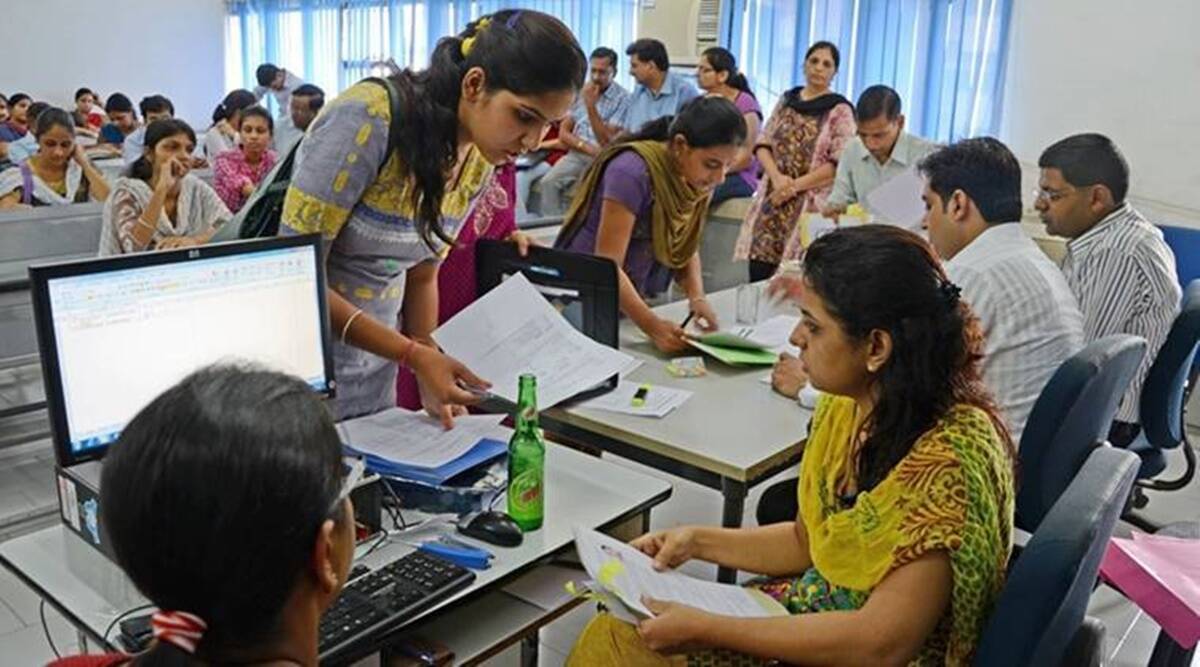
[546, 289, 812, 482]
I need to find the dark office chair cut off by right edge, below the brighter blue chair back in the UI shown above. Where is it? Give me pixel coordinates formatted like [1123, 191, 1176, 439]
[1126, 280, 1200, 531]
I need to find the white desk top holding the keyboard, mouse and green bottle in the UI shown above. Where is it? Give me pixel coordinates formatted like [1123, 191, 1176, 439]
[0, 444, 671, 657]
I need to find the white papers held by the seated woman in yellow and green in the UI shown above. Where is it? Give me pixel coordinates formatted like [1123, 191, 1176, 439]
[574, 525, 787, 618]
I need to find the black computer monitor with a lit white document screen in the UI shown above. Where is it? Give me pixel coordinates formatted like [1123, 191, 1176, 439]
[29, 234, 336, 467]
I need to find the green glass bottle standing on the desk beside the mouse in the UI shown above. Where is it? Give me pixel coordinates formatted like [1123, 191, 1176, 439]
[509, 373, 546, 533]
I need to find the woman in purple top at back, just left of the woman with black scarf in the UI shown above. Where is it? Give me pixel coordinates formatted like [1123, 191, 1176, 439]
[696, 47, 762, 206]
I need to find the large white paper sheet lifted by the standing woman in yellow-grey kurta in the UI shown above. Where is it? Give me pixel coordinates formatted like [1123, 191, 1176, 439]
[433, 274, 636, 409]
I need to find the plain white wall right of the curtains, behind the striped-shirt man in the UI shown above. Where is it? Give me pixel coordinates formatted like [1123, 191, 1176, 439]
[1001, 0, 1200, 227]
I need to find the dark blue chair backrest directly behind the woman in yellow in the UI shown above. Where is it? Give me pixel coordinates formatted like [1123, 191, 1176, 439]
[974, 446, 1138, 667]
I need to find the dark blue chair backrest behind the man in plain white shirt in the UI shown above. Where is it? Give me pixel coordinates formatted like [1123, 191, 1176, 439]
[1016, 334, 1146, 533]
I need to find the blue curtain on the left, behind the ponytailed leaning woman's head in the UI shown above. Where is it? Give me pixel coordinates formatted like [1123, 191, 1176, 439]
[226, 0, 637, 103]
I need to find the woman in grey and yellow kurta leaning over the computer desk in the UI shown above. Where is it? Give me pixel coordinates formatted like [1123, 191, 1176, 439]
[281, 10, 587, 426]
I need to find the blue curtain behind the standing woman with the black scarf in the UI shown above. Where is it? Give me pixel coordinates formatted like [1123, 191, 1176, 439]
[722, 0, 1013, 142]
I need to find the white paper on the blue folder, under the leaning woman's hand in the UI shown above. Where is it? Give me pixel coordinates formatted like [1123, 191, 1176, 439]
[337, 408, 505, 468]
